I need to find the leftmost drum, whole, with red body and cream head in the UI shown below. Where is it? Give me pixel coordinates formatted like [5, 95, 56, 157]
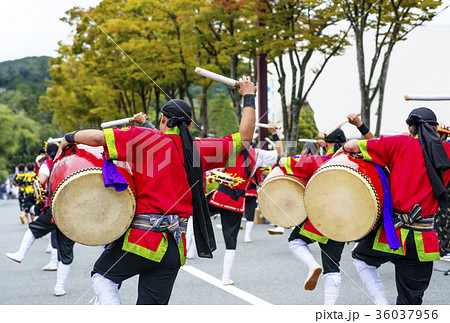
[49, 145, 136, 246]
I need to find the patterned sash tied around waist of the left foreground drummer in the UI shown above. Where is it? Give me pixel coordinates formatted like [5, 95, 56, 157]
[131, 214, 188, 243]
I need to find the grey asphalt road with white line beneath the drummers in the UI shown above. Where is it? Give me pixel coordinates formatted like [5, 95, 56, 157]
[0, 200, 450, 305]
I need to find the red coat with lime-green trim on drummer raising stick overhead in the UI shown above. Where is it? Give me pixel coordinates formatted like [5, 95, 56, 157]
[104, 127, 241, 265]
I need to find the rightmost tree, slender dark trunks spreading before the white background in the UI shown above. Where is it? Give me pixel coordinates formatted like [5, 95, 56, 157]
[335, 0, 442, 136]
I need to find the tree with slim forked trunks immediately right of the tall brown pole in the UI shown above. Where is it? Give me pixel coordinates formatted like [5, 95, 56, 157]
[256, 0, 347, 155]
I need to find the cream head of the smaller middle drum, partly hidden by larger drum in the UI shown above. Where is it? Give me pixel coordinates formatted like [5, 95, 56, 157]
[258, 175, 306, 228]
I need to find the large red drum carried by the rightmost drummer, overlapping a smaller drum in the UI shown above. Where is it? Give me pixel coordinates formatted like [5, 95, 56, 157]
[305, 154, 383, 242]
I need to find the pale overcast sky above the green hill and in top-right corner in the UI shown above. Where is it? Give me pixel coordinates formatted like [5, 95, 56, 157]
[0, 0, 450, 62]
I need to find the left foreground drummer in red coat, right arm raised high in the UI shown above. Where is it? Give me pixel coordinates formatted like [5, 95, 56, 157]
[54, 77, 256, 304]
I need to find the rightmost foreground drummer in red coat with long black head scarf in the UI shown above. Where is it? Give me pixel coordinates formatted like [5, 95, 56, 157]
[336, 108, 450, 304]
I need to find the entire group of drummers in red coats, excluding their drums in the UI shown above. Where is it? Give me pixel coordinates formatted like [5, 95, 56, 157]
[3, 76, 450, 305]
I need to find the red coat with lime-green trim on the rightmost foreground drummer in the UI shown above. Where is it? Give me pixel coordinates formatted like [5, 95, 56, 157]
[359, 136, 450, 261]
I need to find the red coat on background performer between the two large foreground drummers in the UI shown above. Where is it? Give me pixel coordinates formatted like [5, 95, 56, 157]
[209, 148, 258, 213]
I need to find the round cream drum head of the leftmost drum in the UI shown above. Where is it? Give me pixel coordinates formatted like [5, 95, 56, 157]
[52, 168, 136, 246]
